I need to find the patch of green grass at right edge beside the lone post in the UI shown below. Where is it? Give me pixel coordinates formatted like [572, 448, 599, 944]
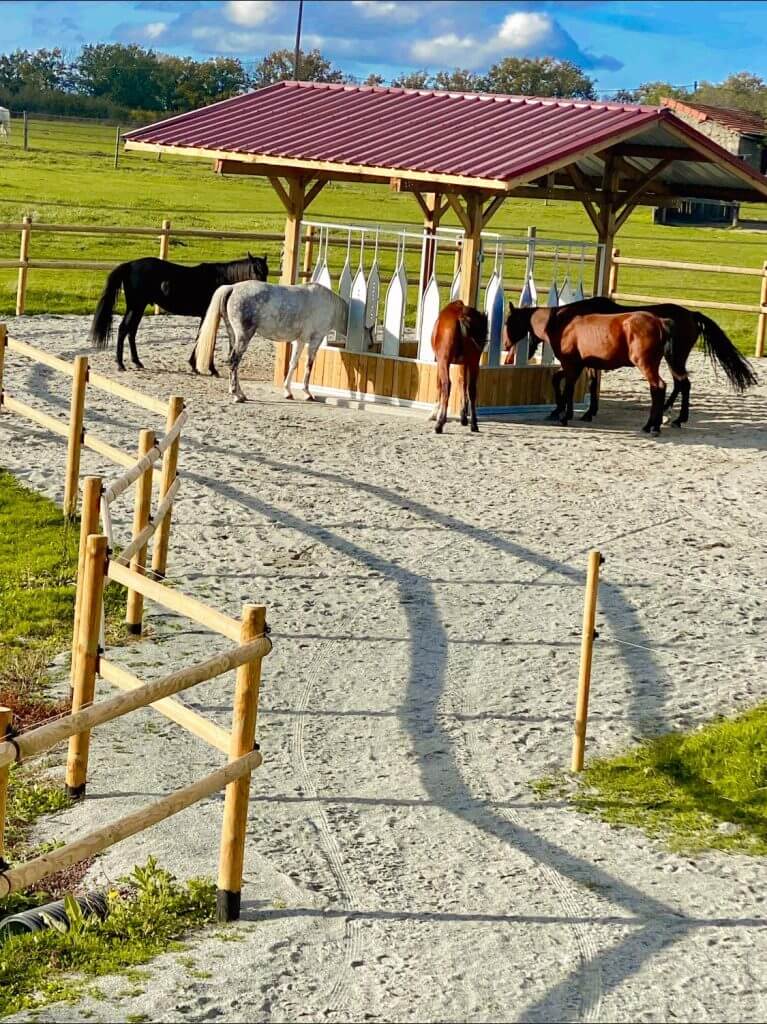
[538, 706, 767, 856]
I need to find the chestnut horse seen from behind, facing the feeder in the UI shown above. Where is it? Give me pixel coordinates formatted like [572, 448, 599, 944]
[429, 299, 487, 434]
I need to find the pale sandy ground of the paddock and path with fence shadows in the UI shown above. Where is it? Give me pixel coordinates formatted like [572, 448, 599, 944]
[0, 317, 767, 1021]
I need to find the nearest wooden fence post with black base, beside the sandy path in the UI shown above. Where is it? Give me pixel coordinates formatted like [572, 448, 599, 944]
[216, 604, 266, 921]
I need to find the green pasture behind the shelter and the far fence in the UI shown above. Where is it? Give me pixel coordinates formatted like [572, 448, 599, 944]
[0, 114, 767, 352]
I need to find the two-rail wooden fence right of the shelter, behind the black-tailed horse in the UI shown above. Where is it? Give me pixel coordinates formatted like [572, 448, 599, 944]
[608, 249, 767, 358]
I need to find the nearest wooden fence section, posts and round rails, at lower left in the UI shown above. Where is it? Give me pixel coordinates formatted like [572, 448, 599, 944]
[0, 520, 271, 921]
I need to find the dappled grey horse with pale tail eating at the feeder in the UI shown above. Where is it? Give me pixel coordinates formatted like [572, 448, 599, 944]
[191, 281, 360, 401]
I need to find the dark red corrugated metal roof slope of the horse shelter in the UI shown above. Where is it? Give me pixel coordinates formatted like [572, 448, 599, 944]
[125, 82, 658, 181]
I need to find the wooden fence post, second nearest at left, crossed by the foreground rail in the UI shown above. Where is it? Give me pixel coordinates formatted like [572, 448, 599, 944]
[67, 535, 108, 800]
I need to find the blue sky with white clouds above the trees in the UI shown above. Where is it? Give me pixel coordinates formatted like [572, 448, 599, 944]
[0, 0, 767, 92]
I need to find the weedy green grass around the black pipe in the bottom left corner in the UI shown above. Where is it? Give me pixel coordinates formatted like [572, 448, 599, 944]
[0, 858, 215, 1020]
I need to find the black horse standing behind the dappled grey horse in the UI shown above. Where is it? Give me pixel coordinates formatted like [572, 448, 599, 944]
[90, 253, 269, 377]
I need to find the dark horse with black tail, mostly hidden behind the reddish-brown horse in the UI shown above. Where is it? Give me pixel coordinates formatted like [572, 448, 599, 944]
[504, 295, 757, 427]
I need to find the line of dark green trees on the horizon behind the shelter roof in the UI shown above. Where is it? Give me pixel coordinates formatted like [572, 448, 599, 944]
[0, 43, 767, 120]
